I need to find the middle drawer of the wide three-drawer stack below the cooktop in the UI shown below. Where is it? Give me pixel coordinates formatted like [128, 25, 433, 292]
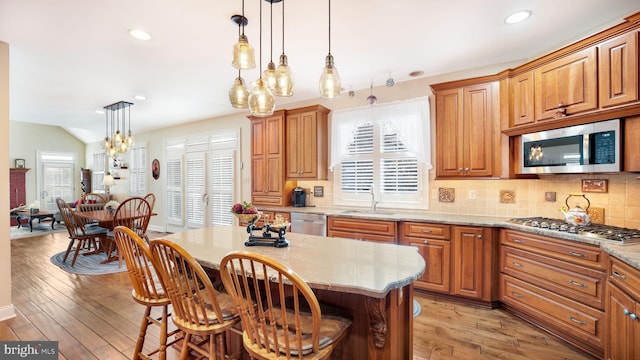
[500, 246, 605, 310]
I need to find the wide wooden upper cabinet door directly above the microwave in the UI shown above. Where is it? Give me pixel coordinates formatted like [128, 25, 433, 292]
[534, 47, 598, 121]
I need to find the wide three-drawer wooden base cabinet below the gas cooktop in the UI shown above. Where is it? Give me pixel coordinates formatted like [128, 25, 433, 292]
[499, 229, 606, 358]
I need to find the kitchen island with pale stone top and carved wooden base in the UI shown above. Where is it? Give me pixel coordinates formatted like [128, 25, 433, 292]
[165, 226, 425, 359]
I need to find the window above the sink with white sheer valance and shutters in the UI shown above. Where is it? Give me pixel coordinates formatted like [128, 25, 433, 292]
[331, 100, 431, 209]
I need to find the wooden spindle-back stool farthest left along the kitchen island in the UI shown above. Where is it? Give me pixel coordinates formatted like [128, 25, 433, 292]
[114, 226, 180, 360]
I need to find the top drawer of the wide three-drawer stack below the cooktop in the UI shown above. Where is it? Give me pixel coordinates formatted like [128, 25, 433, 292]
[500, 230, 605, 270]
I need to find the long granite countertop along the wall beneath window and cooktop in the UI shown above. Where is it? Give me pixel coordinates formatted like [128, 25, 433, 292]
[261, 207, 640, 270]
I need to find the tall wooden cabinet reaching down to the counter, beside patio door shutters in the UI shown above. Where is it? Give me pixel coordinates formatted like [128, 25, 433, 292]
[249, 111, 295, 206]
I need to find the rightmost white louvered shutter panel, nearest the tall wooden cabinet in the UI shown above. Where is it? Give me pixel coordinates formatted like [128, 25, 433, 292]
[209, 150, 235, 226]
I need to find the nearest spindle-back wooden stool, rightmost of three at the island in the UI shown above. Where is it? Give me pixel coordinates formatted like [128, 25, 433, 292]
[220, 251, 352, 359]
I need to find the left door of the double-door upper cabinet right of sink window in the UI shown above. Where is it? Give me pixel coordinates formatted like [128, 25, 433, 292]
[436, 89, 464, 177]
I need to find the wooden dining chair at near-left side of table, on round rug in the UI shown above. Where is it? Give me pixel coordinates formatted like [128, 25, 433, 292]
[56, 198, 107, 266]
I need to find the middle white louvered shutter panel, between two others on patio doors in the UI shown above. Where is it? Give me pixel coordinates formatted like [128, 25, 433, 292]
[185, 153, 205, 227]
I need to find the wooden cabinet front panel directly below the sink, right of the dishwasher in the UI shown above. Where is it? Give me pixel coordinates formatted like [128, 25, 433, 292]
[327, 216, 396, 244]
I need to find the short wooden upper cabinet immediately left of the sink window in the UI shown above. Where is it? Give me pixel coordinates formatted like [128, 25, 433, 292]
[286, 105, 329, 180]
